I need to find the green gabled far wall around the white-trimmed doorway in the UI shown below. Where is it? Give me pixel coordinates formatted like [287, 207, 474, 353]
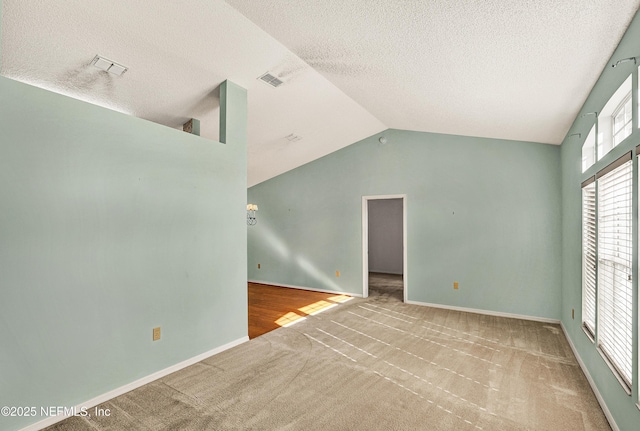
[248, 130, 561, 319]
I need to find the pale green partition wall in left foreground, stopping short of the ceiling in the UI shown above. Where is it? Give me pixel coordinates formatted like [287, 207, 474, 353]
[0, 78, 247, 430]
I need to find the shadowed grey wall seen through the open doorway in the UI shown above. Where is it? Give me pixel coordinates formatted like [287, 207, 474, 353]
[367, 199, 403, 274]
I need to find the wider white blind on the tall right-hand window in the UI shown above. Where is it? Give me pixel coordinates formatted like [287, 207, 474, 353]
[597, 157, 633, 387]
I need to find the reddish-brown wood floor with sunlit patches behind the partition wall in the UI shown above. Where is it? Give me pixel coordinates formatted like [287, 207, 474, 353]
[248, 283, 351, 339]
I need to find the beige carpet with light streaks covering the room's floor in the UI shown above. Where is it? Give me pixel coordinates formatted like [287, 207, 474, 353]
[43, 276, 610, 431]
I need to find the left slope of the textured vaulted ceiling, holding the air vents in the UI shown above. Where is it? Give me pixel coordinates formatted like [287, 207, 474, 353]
[0, 0, 387, 186]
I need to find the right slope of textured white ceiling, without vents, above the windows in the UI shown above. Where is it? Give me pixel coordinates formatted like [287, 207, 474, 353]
[228, 0, 640, 144]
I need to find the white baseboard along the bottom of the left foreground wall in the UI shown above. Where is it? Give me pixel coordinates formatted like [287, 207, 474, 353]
[20, 336, 249, 431]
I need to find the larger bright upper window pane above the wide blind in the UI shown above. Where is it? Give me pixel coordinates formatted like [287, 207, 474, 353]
[597, 75, 632, 160]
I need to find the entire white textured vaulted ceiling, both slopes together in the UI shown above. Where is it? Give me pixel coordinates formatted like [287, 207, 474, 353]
[0, 0, 640, 186]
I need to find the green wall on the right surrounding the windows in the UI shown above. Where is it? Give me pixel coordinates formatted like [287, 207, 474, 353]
[561, 7, 640, 431]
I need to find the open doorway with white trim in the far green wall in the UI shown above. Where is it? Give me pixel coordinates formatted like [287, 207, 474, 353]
[362, 195, 407, 302]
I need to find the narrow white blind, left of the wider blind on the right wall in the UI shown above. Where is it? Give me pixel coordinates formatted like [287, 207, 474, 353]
[582, 180, 596, 337]
